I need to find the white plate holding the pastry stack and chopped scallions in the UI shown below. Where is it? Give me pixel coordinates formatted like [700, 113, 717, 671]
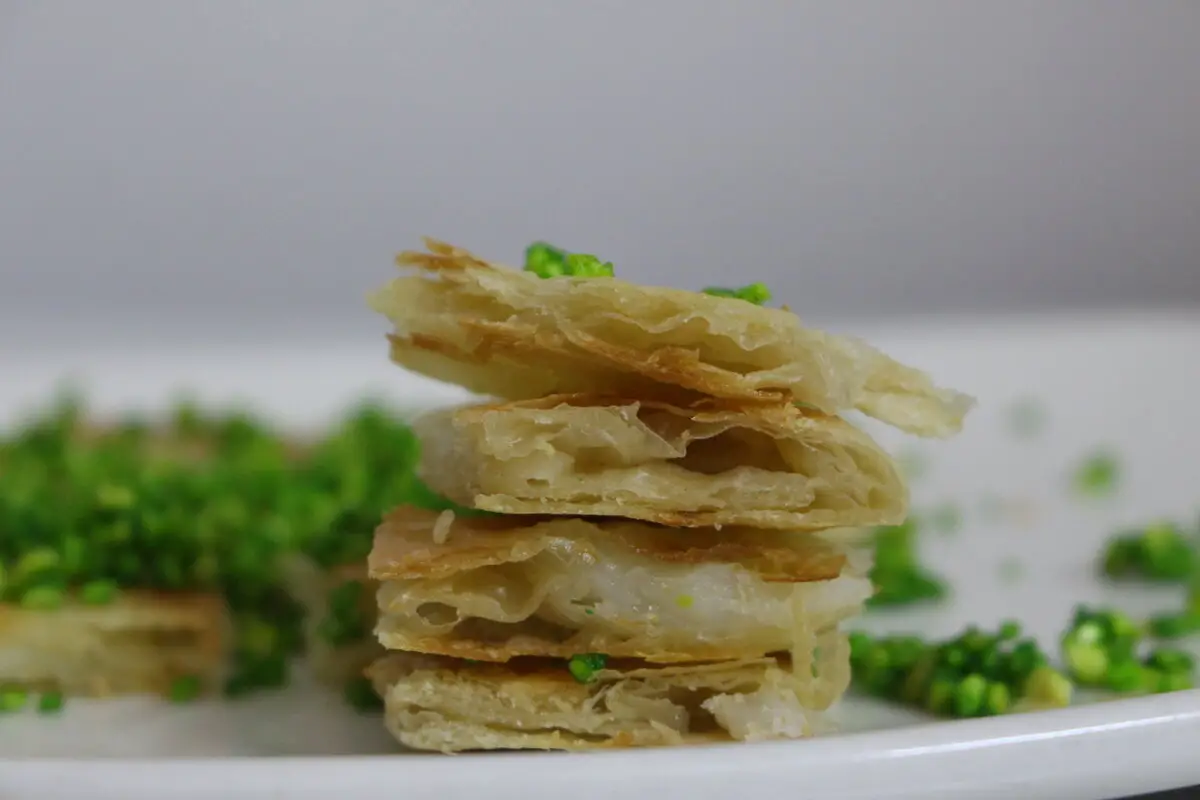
[0, 315, 1200, 800]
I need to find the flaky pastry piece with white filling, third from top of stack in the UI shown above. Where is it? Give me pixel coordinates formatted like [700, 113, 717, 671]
[370, 507, 872, 663]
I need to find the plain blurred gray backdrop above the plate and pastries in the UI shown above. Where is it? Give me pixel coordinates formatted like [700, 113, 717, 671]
[0, 0, 1200, 341]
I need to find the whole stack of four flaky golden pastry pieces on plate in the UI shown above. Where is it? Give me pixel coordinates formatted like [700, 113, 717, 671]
[368, 241, 970, 752]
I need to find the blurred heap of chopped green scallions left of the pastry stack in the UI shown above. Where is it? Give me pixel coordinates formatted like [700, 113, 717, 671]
[0, 398, 448, 711]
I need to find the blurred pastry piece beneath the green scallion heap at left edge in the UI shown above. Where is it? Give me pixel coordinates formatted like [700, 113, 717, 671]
[0, 591, 229, 697]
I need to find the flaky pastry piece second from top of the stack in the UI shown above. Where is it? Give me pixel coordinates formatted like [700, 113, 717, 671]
[414, 395, 907, 530]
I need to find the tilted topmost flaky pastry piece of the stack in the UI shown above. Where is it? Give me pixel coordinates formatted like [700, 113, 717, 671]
[371, 240, 971, 435]
